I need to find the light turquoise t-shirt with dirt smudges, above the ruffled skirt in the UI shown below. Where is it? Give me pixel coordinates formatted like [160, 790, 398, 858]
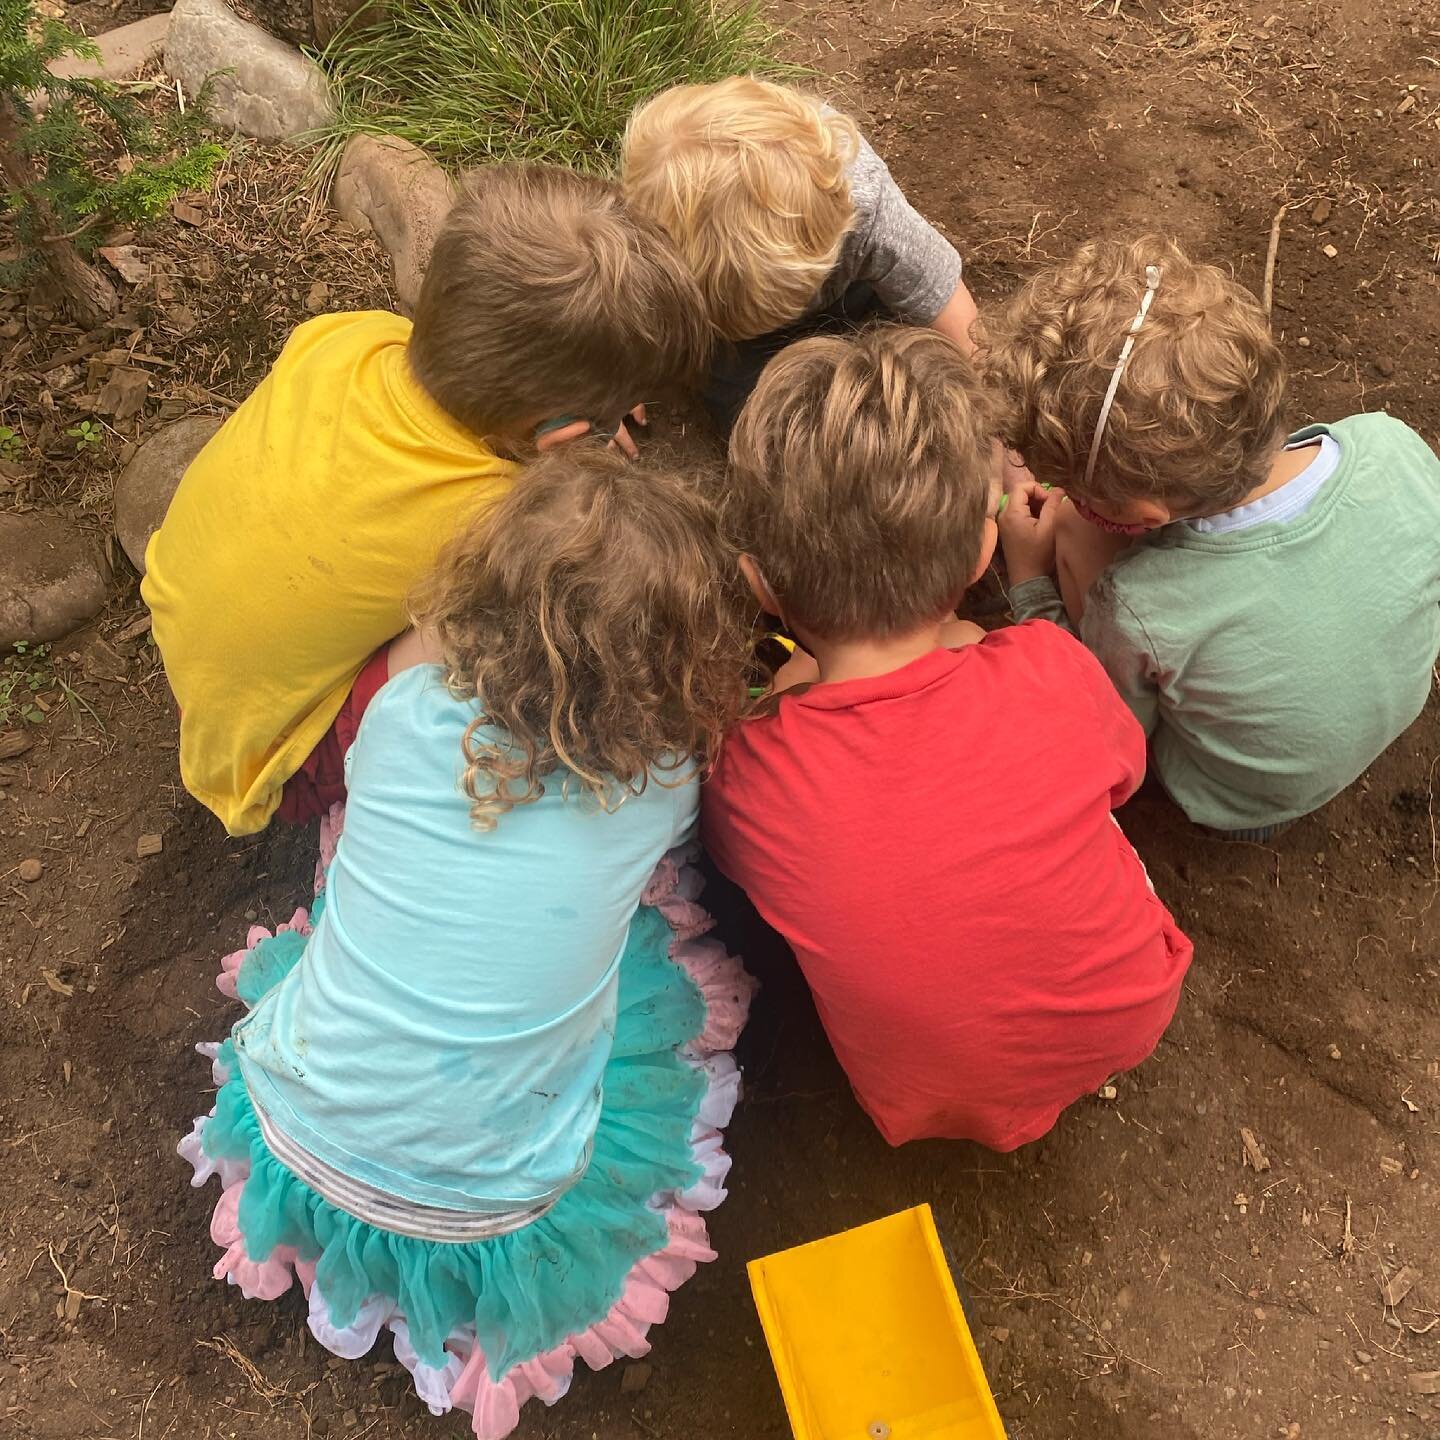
[235, 665, 698, 1212]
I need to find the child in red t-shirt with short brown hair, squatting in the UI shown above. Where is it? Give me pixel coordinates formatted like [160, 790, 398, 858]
[703, 327, 1191, 1151]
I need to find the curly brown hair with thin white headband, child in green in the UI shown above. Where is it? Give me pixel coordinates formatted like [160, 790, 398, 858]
[981, 235, 1284, 513]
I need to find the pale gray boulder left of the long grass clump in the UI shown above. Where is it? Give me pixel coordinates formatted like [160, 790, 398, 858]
[166, 0, 334, 140]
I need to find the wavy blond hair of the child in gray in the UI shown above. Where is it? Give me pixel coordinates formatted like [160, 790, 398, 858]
[621, 75, 860, 340]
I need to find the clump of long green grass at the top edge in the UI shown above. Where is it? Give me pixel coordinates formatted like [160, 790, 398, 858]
[323, 0, 795, 173]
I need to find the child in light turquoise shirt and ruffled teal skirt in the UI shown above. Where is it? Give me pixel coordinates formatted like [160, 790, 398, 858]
[180, 446, 750, 1440]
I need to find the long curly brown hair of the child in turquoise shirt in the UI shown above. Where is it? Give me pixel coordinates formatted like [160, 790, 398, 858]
[412, 442, 753, 829]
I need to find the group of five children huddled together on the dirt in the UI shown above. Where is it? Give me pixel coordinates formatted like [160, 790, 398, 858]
[144, 78, 1440, 1440]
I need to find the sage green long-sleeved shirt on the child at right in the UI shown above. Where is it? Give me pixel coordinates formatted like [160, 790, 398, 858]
[1012, 415, 1440, 831]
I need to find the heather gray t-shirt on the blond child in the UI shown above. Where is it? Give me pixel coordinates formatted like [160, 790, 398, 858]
[837, 138, 962, 325]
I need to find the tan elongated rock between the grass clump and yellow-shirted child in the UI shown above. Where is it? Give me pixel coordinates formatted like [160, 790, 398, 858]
[331, 135, 455, 314]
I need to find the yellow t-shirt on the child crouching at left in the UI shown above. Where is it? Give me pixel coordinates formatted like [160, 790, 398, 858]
[141, 311, 516, 835]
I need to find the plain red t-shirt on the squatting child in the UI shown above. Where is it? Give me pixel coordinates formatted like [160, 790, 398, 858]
[701, 621, 1192, 1151]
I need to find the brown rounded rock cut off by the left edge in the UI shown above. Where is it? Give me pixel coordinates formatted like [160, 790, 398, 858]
[0, 514, 109, 649]
